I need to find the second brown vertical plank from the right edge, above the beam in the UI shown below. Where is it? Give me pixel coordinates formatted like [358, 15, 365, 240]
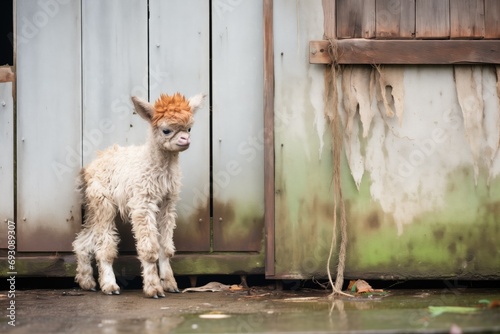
[450, 0, 484, 39]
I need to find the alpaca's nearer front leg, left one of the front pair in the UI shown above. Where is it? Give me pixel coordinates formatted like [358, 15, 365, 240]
[132, 206, 165, 298]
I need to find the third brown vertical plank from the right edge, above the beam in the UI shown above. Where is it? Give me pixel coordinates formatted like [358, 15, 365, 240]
[415, 0, 454, 39]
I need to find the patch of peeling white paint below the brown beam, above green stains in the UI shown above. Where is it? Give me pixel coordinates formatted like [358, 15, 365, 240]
[339, 66, 500, 234]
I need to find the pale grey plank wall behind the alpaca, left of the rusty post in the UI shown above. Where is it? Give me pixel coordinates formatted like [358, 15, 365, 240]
[9, 0, 264, 260]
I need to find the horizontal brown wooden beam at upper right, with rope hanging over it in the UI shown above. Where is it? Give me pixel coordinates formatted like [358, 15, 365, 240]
[309, 39, 500, 65]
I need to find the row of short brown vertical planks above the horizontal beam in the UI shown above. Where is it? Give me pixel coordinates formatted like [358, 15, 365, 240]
[335, 0, 500, 39]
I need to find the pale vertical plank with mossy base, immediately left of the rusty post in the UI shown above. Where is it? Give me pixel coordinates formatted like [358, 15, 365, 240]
[212, 0, 264, 251]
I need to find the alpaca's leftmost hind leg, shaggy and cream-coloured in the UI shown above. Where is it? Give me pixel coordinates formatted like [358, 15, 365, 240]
[73, 227, 96, 291]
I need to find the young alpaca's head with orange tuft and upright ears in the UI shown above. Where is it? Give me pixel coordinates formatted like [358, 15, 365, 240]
[132, 93, 204, 152]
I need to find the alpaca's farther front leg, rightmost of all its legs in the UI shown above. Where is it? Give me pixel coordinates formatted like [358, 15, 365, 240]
[159, 202, 179, 292]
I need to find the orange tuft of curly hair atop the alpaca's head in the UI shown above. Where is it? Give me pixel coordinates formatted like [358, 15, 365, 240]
[152, 93, 193, 126]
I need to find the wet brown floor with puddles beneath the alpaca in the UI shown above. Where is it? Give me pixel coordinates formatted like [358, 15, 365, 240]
[0, 287, 500, 333]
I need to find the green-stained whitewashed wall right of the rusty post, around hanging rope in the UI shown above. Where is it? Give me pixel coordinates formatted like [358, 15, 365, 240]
[273, 0, 500, 279]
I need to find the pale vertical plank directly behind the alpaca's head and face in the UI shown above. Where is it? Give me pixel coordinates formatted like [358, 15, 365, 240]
[149, 0, 211, 251]
